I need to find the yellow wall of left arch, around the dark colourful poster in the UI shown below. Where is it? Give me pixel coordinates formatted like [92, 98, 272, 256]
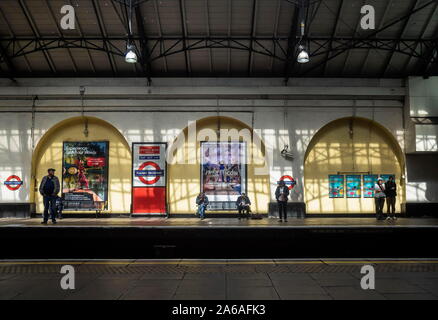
[32, 117, 131, 213]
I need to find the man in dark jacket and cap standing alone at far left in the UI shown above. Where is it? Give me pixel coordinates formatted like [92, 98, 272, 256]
[39, 168, 60, 224]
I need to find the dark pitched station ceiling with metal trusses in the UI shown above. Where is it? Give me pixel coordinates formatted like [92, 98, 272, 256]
[0, 0, 438, 79]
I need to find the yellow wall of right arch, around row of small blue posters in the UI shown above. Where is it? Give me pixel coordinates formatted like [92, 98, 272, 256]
[304, 118, 405, 214]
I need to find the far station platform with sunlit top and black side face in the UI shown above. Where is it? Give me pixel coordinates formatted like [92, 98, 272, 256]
[0, 218, 438, 259]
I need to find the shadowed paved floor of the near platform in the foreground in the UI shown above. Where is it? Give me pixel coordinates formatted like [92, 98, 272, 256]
[0, 259, 438, 300]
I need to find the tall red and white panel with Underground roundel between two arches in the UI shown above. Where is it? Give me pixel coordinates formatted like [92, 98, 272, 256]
[132, 142, 167, 215]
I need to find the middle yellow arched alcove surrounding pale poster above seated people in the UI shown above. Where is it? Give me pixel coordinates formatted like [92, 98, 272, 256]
[167, 116, 270, 214]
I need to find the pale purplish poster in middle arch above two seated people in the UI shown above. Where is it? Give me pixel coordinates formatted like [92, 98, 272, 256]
[201, 142, 246, 202]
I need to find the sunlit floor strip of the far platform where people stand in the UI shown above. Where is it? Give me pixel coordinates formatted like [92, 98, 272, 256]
[0, 217, 438, 228]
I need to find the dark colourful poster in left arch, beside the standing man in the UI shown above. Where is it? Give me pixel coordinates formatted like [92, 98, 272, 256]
[62, 141, 109, 210]
